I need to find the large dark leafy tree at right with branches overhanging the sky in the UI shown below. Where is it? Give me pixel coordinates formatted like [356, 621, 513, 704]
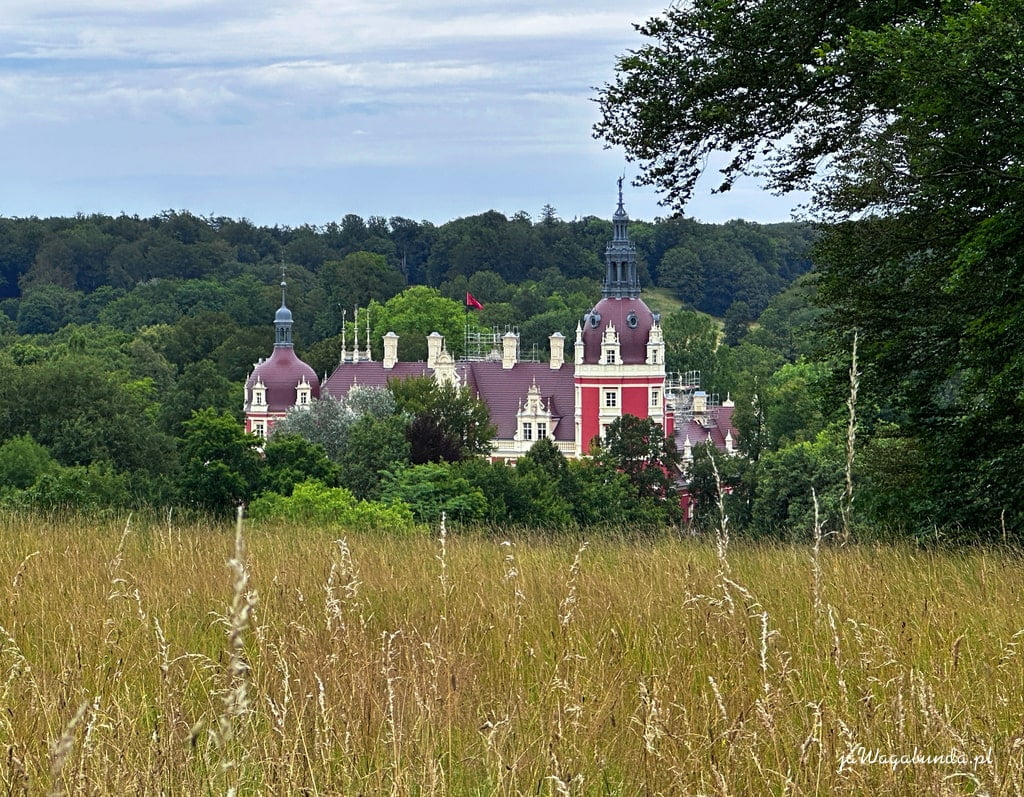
[597, 0, 1024, 533]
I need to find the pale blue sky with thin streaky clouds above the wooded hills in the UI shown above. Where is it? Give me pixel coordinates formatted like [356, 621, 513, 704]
[0, 0, 797, 226]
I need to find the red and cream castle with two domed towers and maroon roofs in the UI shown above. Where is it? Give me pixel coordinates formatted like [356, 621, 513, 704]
[245, 180, 737, 462]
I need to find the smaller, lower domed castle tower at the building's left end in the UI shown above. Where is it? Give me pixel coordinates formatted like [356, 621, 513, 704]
[244, 280, 319, 437]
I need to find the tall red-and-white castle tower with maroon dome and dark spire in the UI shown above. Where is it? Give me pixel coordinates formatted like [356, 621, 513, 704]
[575, 178, 673, 454]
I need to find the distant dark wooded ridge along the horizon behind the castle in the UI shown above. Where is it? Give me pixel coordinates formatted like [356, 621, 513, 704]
[0, 207, 813, 331]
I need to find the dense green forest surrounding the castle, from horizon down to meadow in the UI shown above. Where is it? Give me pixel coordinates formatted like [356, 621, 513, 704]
[0, 206, 823, 523]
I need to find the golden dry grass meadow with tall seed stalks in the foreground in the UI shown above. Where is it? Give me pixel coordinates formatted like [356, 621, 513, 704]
[0, 515, 1024, 795]
